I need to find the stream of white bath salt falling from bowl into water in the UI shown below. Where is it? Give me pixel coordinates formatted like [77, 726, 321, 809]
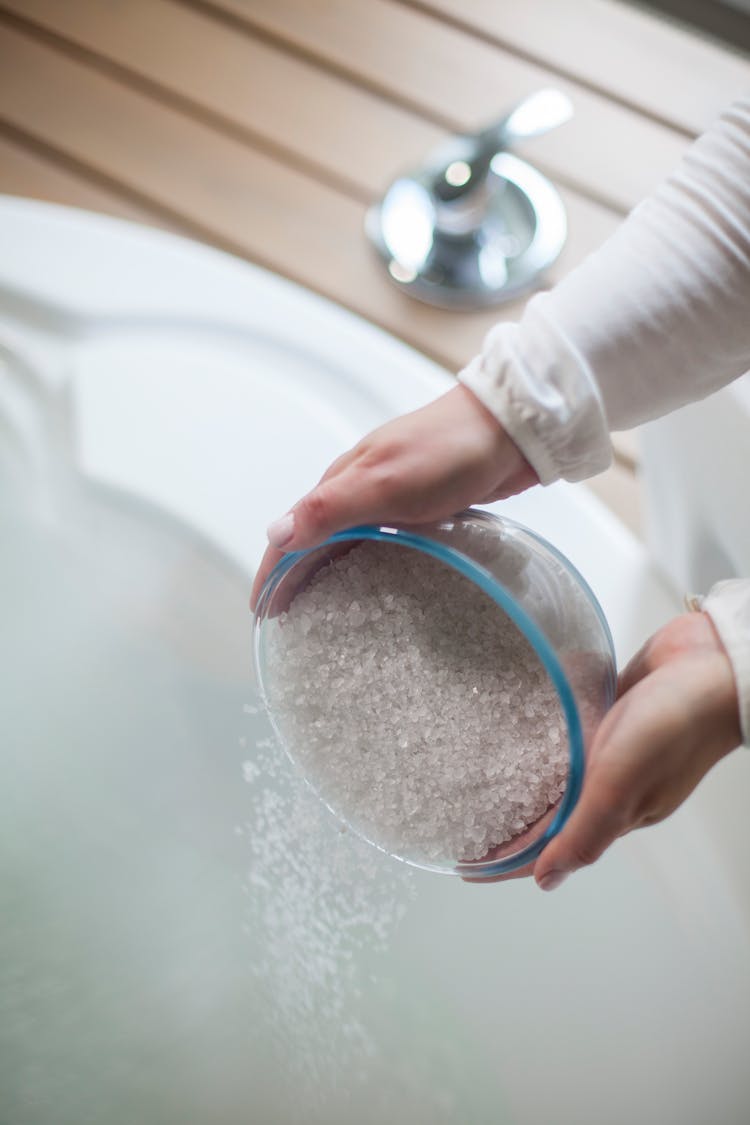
[240, 738, 416, 1107]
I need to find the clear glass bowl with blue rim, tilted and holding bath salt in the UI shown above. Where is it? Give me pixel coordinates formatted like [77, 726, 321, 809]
[253, 509, 616, 880]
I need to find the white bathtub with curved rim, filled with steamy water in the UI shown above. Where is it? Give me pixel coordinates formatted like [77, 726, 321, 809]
[0, 203, 750, 1125]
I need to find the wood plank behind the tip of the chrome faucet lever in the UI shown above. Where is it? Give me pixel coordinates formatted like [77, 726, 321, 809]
[173, 0, 687, 212]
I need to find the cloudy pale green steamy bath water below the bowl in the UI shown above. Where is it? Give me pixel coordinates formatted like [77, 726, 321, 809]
[0, 474, 747, 1125]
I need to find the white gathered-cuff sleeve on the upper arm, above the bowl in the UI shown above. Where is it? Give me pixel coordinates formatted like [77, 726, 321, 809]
[459, 96, 750, 484]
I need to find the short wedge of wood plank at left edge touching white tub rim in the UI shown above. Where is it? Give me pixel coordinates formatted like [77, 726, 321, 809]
[0, 127, 180, 231]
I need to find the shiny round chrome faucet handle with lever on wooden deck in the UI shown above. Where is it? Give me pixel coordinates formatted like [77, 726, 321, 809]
[365, 89, 572, 308]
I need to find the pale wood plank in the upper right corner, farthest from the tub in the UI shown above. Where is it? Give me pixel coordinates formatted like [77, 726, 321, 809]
[403, 0, 750, 134]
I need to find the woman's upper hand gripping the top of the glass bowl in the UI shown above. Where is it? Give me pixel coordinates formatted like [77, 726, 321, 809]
[251, 385, 537, 609]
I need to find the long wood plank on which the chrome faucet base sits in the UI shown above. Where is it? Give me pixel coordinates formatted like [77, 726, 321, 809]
[0, 17, 614, 369]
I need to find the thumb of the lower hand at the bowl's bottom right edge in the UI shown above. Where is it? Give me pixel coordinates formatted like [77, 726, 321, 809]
[534, 775, 625, 891]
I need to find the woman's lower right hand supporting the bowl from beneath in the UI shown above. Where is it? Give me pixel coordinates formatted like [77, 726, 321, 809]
[533, 613, 742, 891]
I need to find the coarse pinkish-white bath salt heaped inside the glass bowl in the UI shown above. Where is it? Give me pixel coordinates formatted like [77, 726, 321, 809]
[268, 541, 568, 865]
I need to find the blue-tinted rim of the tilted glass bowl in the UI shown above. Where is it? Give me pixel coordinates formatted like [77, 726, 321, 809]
[253, 509, 615, 880]
